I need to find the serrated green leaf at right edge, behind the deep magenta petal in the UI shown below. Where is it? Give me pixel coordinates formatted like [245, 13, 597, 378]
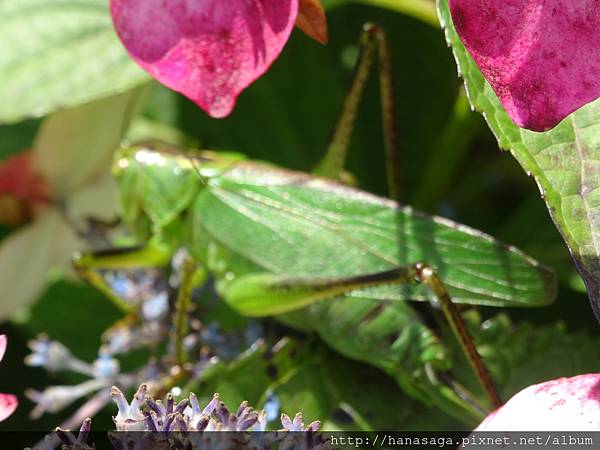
[438, 0, 600, 318]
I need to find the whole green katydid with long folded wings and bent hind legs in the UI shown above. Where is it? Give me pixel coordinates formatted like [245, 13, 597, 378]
[75, 26, 555, 426]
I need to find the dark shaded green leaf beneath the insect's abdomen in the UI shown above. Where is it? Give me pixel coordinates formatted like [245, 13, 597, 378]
[186, 338, 457, 430]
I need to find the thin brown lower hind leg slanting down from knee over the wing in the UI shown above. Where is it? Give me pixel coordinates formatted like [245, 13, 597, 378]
[414, 263, 503, 409]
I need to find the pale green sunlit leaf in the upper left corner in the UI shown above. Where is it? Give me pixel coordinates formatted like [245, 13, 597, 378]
[0, 0, 148, 122]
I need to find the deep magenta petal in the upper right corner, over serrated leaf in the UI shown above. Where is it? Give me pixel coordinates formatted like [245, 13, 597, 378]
[449, 0, 600, 131]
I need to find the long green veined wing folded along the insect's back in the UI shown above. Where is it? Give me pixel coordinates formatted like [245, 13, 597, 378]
[194, 164, 555, 306]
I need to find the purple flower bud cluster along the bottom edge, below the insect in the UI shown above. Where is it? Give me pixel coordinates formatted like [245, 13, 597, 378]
[47, 384, 325, 450]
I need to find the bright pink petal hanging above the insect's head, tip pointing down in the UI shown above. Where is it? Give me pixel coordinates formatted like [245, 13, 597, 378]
[110, 0, 298, 117]
